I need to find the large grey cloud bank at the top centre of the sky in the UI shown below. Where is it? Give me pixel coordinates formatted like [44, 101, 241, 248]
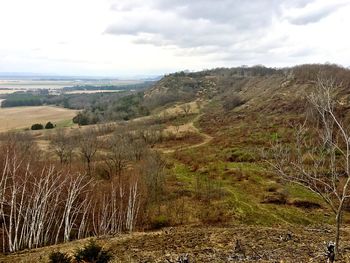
[105, 0, 320, 63]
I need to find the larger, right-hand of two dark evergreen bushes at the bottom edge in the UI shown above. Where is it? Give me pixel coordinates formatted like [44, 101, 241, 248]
[74, 240, 113, 263]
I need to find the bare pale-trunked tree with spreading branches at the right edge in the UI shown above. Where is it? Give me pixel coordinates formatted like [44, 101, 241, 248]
[272, 78, 350, 254]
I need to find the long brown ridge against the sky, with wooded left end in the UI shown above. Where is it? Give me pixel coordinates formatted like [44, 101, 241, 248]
[65, 64, 350, 127]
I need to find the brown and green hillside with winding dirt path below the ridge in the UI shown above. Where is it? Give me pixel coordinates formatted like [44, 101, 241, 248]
[0, 65, 350, 262]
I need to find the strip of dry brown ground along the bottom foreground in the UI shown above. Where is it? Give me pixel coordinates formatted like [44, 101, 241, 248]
[0, 226, 350, 263]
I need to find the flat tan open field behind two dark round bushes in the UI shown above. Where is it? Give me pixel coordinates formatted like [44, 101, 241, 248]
[0, 106, 76, 132]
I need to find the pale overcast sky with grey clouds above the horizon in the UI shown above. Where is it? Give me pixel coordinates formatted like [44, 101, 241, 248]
[0, 0, 350, 76]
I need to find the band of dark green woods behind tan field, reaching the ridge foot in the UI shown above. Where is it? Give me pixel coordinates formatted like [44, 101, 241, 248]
[1, 88, 152, 125]
